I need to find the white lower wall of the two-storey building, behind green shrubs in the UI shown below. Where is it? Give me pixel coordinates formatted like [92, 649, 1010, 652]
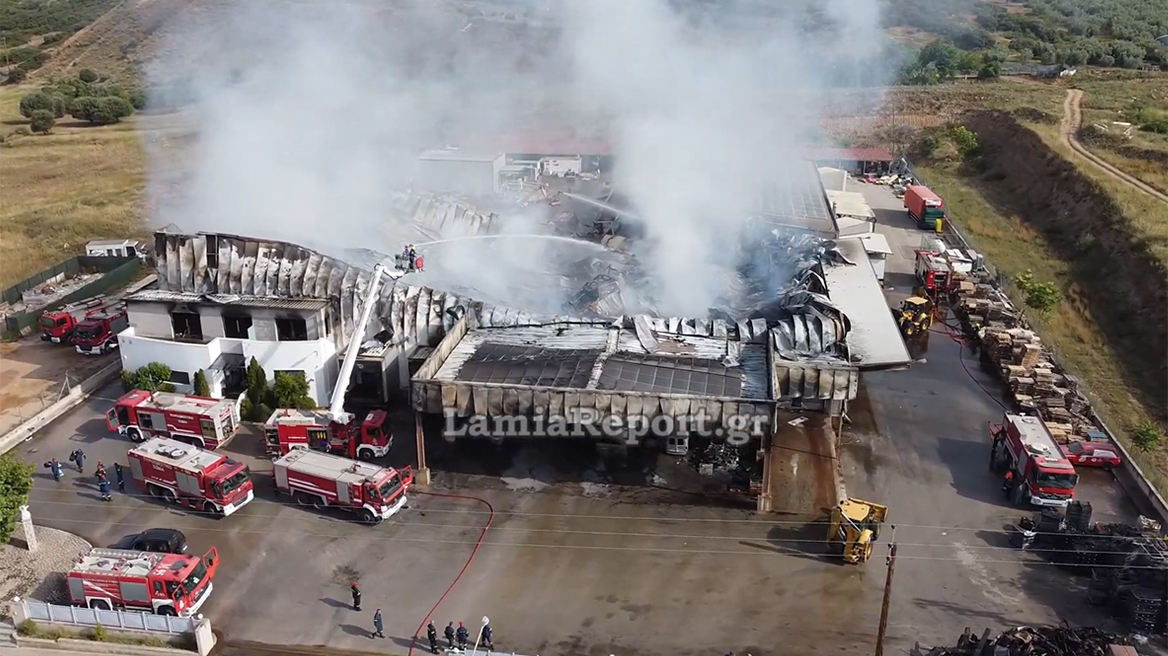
[118, 327, 340, 406]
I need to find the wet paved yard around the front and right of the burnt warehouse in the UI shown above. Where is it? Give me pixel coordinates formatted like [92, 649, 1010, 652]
[16, 359, 1125, 656]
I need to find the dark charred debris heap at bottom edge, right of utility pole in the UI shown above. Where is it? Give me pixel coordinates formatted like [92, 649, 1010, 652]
[910, 627, 1129, 656]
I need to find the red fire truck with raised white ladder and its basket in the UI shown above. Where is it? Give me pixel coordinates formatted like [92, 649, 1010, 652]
[264, 257, 422, 460]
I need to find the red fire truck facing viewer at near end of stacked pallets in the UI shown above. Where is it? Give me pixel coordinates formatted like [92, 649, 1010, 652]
[989, 414, 1079, 508]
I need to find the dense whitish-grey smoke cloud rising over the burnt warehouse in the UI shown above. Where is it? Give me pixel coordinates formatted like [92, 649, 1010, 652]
[151, 0, 883, 315]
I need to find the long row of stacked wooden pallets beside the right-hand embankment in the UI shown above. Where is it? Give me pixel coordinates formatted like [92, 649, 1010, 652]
[951, 271, 1104, 444]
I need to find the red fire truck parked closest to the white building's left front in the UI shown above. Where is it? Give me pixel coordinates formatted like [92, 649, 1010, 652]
[105, 390, 243, 449]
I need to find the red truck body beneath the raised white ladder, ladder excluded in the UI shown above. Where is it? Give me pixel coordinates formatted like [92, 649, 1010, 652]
[264, 409, 394, 460]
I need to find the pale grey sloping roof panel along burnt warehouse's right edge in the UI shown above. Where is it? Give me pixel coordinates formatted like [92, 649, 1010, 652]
[823, 239, 912, 369]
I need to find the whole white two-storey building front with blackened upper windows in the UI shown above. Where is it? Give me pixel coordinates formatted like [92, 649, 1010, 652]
[118, 289, 339, 406]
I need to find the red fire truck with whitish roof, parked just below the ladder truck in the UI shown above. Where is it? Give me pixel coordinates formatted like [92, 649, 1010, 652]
[273, 448, 413, 524]
